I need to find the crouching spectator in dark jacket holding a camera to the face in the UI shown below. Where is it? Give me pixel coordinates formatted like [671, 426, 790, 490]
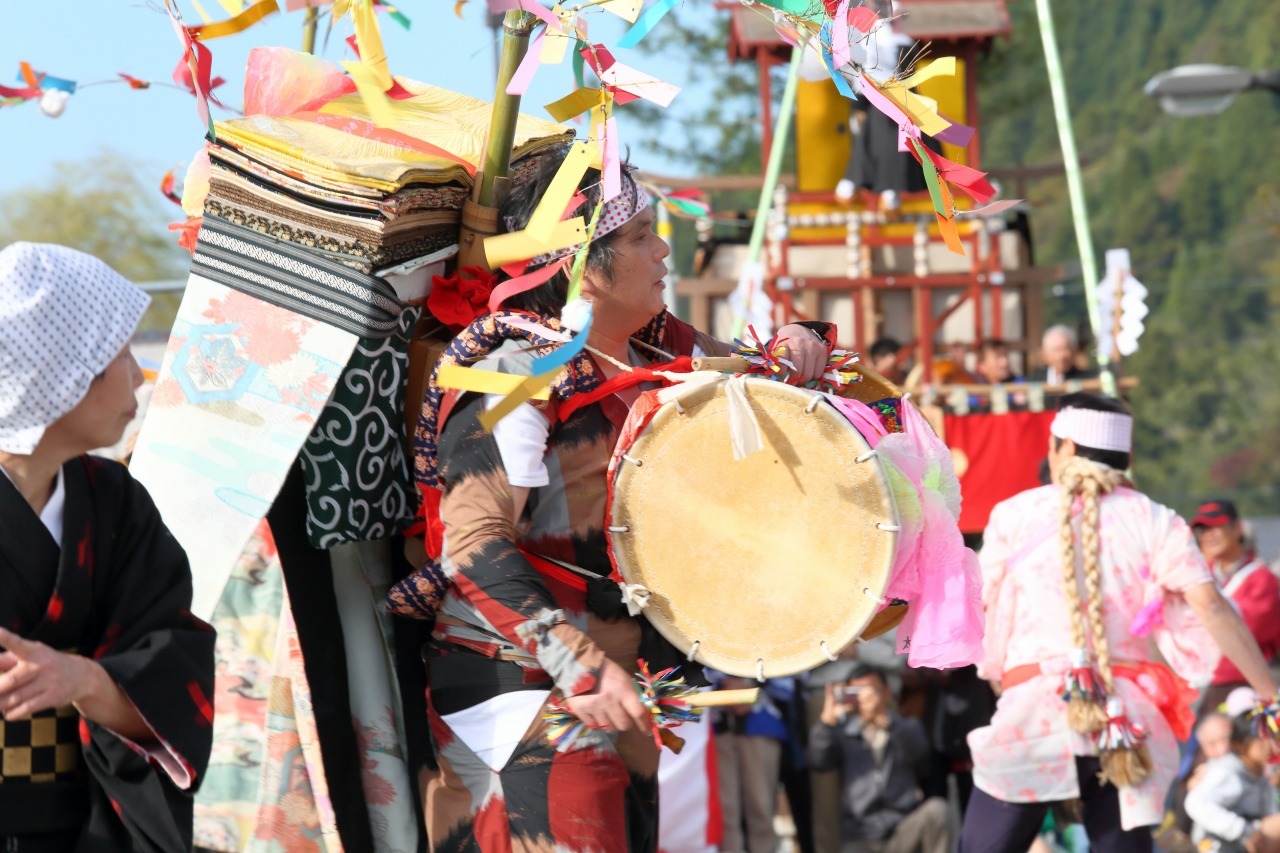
[809, 661, 952, 853]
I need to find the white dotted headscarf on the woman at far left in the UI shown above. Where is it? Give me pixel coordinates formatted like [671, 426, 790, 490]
[0, 243, 151, 455]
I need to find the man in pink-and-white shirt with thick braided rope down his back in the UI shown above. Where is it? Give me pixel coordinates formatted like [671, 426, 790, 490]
[960, 393, 1276, 853]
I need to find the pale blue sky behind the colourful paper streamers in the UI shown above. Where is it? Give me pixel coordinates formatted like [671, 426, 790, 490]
[0, 0, 709, 195]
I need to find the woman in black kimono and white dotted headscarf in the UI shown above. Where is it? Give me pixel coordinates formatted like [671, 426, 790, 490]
[0, 243, 214, 853]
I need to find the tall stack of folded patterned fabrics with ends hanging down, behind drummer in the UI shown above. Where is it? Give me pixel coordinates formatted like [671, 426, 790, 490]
[136, 66, 572, 604]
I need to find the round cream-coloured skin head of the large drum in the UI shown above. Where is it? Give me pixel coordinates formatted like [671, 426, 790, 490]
[609, 379, 897, 678]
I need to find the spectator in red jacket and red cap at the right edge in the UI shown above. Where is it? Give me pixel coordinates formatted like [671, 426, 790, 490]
[1192, 501, 1280, 711]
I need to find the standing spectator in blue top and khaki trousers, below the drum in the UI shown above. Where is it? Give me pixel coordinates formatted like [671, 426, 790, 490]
[712, 674, 795, 853]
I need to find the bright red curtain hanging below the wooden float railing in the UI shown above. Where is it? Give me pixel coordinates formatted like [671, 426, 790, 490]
[943, 411, 1055, 533]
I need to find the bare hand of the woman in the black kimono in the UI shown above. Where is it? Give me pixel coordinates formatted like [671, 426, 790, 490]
[0, 628, 97, 720]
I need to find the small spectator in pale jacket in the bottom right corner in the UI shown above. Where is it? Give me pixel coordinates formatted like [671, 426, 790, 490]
[1187, 712, 1280, 853]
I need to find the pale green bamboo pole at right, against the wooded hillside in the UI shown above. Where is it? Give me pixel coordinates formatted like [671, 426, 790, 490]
[1036, 0, 1116, 397]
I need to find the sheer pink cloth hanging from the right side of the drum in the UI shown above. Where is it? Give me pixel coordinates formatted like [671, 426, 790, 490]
[829, 397, 983, 669]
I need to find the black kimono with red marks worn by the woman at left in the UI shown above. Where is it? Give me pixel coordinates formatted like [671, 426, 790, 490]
[0, 456, 214, 853]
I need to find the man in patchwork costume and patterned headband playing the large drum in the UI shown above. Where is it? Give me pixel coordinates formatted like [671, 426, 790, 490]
[390, 151, 832, 852]
